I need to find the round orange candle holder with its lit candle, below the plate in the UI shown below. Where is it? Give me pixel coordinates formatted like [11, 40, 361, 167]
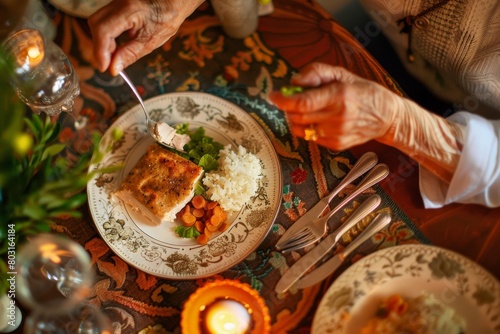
[181, 280, 271, 334]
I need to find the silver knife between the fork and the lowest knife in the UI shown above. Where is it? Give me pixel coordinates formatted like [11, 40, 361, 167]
[274, 194, 382, 293]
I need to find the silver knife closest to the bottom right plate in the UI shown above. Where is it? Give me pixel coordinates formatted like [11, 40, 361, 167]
[297, 212, 391, 289]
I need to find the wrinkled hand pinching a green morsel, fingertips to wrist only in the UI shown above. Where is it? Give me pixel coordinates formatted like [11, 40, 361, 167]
[270, 63, 403, 151]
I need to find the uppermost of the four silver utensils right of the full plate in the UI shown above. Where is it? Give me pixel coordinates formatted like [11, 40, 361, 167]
[276, 152, 378, 250]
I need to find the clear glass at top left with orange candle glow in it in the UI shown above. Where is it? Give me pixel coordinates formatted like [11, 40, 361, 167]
[4, 29, 87, 129]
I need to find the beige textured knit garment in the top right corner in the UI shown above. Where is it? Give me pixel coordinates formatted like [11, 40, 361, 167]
[361, 0, 500, 119]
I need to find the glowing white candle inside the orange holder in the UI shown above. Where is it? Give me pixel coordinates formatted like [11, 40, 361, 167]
[201, 299, 252, 334]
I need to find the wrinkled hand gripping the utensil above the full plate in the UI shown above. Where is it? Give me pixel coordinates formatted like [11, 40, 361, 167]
[88, 0, 204, 76]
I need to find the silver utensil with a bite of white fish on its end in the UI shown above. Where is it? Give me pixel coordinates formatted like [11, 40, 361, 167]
[119, 71, 191, 153]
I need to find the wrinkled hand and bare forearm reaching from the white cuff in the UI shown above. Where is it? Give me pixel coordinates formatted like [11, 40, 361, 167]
[270, 63, 463, 182]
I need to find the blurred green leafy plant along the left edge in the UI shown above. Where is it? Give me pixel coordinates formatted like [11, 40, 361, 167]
[0, 49, 118, 293]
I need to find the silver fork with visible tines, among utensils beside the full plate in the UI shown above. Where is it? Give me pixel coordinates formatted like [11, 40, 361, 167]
[281, 164, 389, 252]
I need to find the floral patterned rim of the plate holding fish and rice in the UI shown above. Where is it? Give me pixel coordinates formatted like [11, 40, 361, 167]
[87, 92, 282, 279]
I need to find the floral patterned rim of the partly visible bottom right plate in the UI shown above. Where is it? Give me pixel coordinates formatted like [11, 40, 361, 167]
[312, 245, 500, 334]
